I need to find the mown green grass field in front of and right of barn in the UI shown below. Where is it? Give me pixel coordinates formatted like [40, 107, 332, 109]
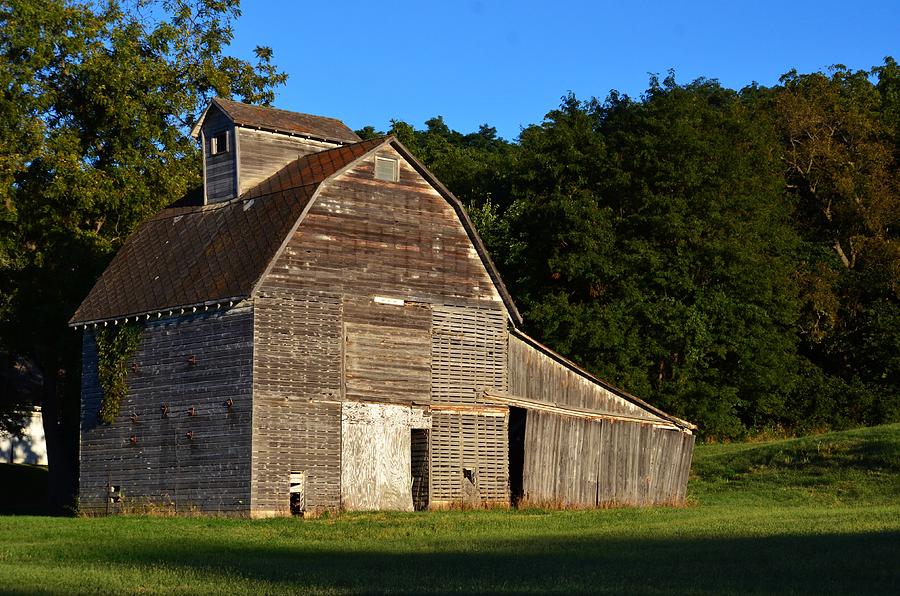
[0, 425, 900, 594]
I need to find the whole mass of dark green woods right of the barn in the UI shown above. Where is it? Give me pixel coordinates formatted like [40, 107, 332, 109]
[380, 58, 900, 438]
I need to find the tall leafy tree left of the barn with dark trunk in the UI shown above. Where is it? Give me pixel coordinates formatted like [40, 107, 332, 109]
[0, 0, 286, 506]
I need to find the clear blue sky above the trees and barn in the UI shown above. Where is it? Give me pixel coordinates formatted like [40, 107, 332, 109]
[232, 0, 900, 139]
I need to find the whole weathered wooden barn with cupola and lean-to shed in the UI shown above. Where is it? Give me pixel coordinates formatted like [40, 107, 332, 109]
[71, 100, 694, 516]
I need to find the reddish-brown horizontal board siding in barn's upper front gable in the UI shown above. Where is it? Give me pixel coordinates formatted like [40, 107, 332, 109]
[264, 150, 503, 309]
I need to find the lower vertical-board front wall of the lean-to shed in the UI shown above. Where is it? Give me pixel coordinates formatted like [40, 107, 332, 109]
[523, 410, 694, 507]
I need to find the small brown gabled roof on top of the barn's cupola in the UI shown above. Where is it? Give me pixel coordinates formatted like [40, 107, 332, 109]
[191, 97, 362, 143]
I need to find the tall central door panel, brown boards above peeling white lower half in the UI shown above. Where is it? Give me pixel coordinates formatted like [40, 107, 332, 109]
[341, 296, 431, 511]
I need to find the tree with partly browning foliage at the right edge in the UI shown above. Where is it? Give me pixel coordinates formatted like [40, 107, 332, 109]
[775, 58, 900, 425]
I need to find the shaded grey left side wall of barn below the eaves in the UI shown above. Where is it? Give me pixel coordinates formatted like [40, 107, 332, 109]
[79, 308, 253, 513]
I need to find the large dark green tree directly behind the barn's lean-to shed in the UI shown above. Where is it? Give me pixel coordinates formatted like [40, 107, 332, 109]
[507, 76, 797, 436]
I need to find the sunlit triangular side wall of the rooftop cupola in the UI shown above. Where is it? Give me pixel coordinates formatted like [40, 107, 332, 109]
[238, 127, 338, 194]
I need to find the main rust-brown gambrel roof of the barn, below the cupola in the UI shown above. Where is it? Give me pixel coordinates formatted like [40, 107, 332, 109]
[69, 137, 521, 325]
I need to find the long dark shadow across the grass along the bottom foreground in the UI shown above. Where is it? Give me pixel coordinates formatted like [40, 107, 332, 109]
[59, 532, 900, 594]
